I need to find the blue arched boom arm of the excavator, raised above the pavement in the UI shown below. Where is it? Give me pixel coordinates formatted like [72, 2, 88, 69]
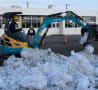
[33, 11, 88, 48]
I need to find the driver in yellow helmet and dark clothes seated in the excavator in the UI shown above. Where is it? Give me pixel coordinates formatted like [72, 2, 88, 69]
[9, 16, 20, 33]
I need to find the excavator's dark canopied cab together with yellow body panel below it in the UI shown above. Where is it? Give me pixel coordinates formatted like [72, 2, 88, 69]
[1, 12, 28, 48]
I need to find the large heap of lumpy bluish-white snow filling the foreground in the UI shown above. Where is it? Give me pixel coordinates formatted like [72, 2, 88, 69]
[0, 45, 98, 90]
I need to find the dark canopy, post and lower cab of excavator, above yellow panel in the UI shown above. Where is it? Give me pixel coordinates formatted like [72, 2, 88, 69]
[3, 12, 26, 42]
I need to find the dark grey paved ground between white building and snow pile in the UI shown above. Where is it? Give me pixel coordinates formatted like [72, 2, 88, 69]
[41, 35, 98, 56]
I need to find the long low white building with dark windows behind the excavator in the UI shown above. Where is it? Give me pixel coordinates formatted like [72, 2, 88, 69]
[0, 6, 98, 35]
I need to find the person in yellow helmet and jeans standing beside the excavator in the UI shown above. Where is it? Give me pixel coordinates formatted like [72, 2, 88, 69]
[27, 26, 35, 47]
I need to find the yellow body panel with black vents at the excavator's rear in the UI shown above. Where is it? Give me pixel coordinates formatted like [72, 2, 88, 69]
[1, 34, 28, 48]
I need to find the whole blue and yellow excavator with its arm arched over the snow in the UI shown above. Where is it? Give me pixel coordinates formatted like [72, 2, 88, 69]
[0, 11, 96, 56]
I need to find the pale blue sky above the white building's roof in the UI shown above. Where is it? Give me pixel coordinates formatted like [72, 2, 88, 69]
[0, 0, 98, 10]
